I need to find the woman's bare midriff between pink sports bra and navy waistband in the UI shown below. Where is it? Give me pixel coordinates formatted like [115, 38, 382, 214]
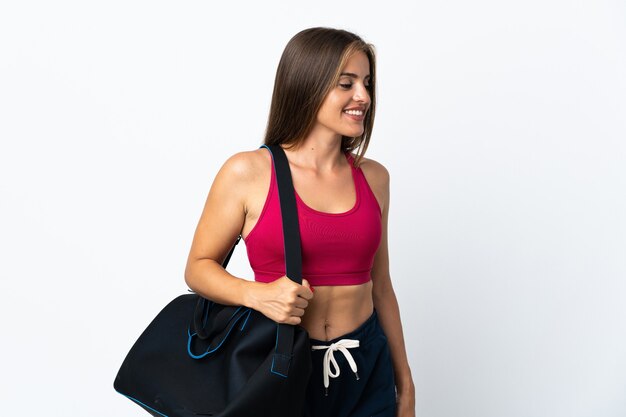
[300, 277, 374, 341]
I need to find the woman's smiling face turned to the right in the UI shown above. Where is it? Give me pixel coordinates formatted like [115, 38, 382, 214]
[317, 51, 370, 137]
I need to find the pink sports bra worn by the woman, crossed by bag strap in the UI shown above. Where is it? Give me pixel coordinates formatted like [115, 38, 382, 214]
[244, 147, 382, 286]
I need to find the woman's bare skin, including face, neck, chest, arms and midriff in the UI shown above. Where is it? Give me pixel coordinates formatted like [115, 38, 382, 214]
[185, 52, 415, 417]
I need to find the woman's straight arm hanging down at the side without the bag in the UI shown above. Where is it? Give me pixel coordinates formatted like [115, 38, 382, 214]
[370, 158, 415, 417]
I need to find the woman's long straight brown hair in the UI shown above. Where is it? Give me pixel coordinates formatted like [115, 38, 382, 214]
[264, 27, 376, 166]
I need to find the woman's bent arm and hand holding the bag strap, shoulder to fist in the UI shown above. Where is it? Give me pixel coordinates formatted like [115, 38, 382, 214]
[185, 152, 313, 324]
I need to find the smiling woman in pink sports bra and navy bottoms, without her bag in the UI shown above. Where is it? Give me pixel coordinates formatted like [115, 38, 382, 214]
[185, 28, 415, 417]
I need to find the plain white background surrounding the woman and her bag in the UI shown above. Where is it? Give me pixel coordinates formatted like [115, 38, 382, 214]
[0, 0, 626, 417]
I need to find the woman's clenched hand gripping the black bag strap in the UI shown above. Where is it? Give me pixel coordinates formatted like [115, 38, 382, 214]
[244, 275, 313, 325]
